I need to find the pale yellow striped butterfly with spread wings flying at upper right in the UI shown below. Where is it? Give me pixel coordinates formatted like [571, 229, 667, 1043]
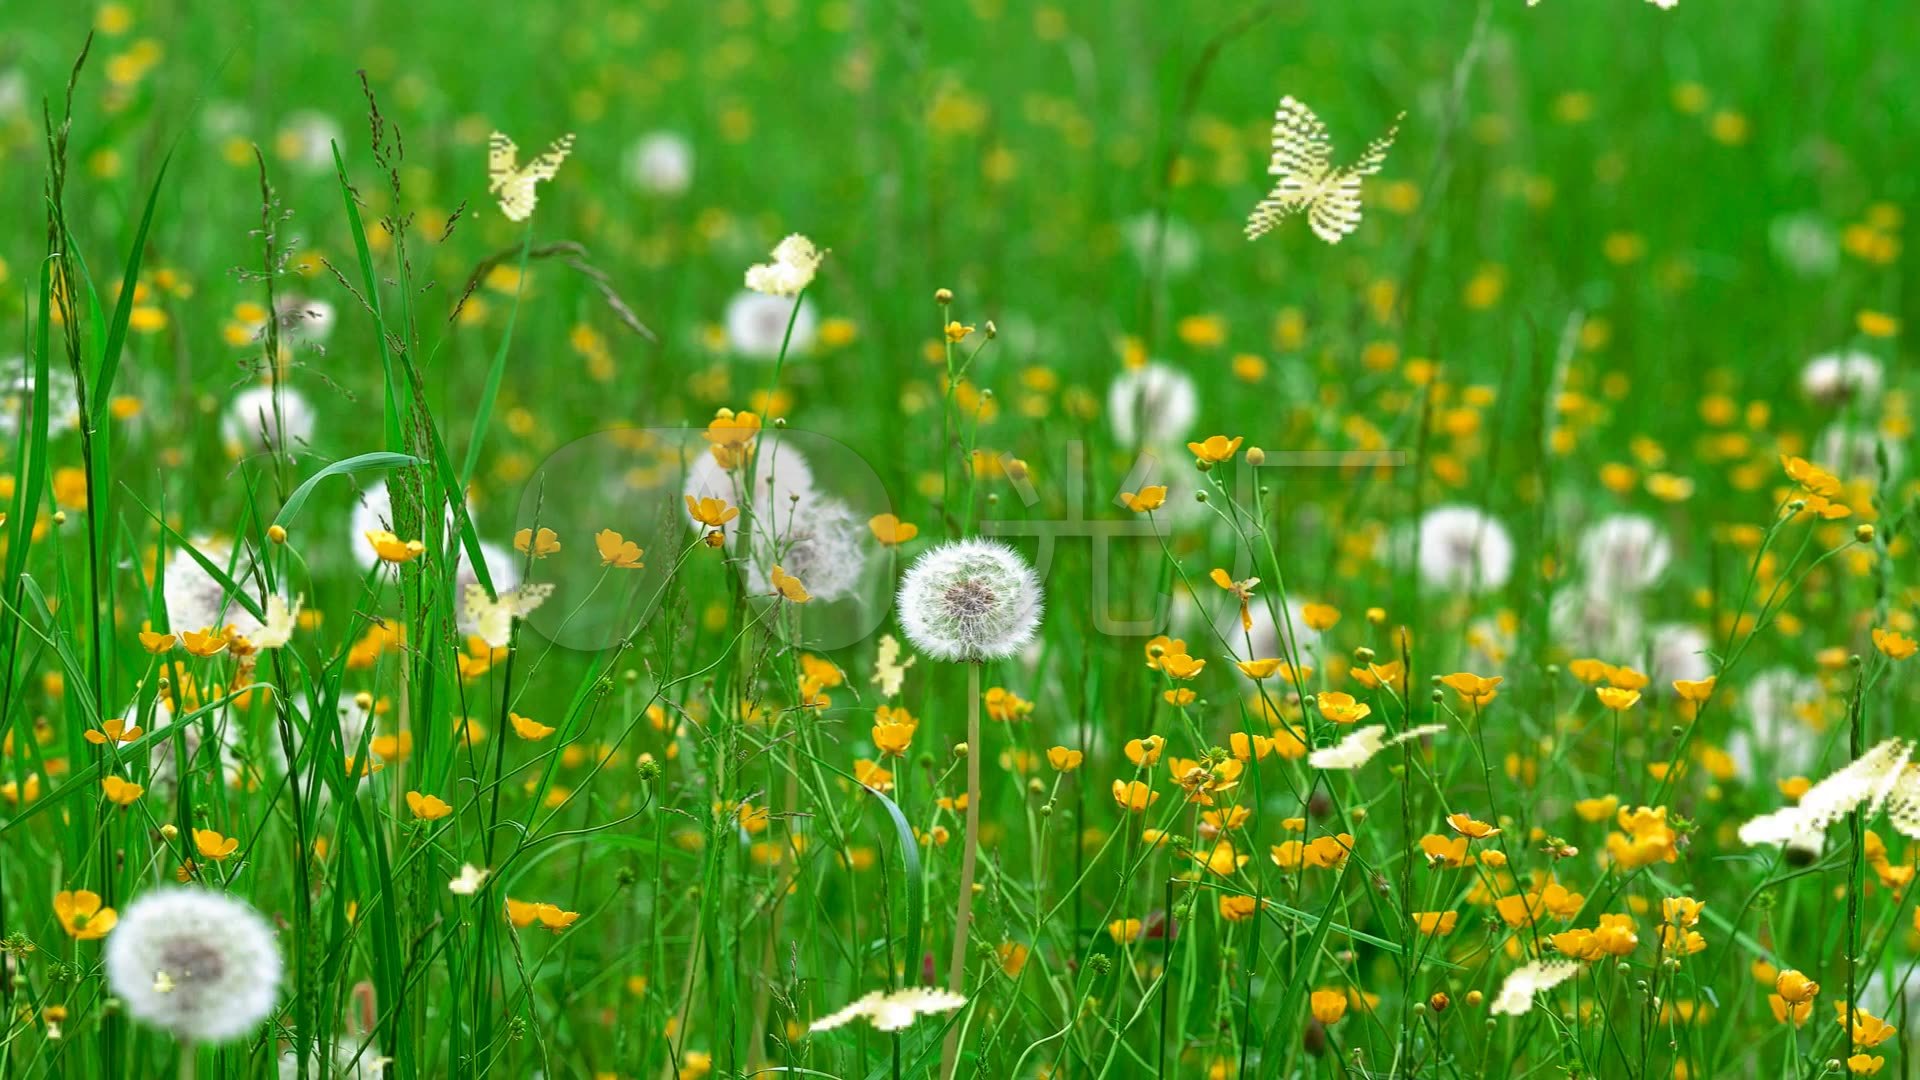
[1246, 96, 1405, 244]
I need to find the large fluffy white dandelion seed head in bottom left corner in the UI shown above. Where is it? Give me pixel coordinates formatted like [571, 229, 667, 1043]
[106, 888, 280, 1043]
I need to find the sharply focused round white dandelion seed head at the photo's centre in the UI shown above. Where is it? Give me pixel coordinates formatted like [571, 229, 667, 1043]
[894, 540, 1041, 661]
